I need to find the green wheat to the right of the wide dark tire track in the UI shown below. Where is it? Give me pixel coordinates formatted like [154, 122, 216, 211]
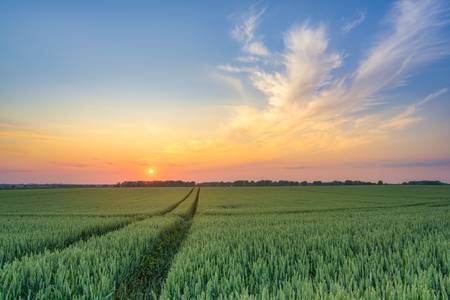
[162, 186, 450, 299]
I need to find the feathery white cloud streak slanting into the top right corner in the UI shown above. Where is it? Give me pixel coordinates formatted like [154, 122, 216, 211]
[350, 0, 450, 106]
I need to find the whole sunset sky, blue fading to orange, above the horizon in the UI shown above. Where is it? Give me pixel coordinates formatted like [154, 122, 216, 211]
[0, 0, 450, 183]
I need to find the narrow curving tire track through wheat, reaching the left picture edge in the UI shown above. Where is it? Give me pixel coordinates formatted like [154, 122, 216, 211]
[0, 187, 195, 268]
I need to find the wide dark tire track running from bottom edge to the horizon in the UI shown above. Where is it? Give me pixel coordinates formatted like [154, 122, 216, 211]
[115, 187, 200, 299]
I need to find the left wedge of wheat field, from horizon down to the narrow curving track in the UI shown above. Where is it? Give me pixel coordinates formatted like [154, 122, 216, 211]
[0, 188, 192, 267]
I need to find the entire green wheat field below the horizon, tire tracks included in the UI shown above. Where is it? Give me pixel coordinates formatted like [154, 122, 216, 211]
[0, 186, 450, 299]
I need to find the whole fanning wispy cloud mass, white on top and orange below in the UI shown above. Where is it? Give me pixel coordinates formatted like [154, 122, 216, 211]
[163, 0, 450, 170]
